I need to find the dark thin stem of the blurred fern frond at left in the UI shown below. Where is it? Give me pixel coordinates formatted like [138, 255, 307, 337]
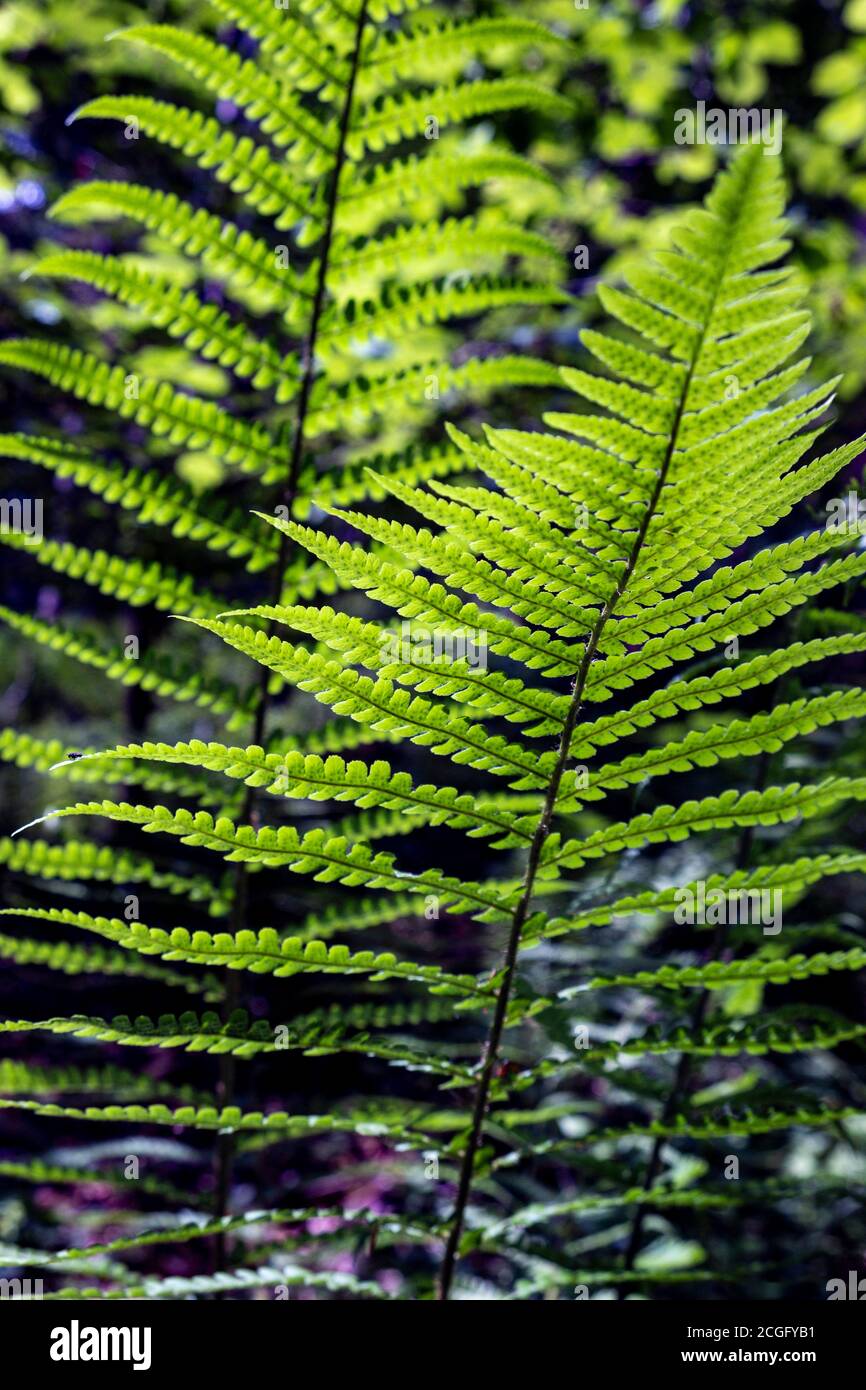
[214, 0, 370, 1269]
